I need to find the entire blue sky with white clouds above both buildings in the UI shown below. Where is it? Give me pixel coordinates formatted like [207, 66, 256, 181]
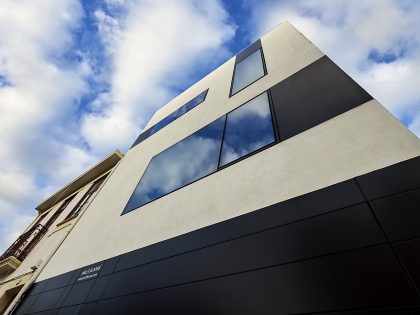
[0, 0, 420, 251]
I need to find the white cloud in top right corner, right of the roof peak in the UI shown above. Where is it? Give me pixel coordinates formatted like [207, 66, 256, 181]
[249, 0, 420, 136]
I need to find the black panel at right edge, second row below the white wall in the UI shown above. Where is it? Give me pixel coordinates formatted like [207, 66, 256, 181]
[371, 189, 420, 242]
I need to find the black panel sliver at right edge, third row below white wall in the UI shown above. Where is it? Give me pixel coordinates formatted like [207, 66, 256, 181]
[394, 239, 420, 290]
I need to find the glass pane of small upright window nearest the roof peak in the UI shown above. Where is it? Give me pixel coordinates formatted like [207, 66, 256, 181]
[232, 49, 264, 95]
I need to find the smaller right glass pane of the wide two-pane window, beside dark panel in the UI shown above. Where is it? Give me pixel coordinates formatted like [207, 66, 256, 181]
[220, 93, 275, 166]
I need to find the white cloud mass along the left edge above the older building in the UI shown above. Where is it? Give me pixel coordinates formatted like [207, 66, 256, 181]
[0, 0, 98, 251]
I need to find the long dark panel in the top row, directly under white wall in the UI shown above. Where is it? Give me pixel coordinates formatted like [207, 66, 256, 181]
[115, 180, 364, 271]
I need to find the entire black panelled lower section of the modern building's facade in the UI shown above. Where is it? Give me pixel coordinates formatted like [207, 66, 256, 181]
[17, 157, 420, 314]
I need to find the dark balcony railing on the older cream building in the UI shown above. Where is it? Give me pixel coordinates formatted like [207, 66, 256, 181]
[0, 224, 48, 261]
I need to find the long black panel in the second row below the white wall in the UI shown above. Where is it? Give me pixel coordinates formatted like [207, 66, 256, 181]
[103, 205, 386, 298]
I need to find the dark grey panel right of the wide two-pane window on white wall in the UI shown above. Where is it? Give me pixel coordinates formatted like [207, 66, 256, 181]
[271, 56, 372, 140]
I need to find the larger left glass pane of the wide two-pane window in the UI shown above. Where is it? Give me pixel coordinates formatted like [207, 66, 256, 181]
[123, 116, 225, 213]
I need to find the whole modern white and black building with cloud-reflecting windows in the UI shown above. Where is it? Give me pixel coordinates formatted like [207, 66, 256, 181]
[4, 23, 420, 315]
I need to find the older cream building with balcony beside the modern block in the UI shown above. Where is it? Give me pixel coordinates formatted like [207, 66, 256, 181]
[0, 151, 123, 314]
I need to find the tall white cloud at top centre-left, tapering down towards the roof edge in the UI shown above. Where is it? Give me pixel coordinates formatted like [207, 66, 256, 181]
[82, 0, 234, 152]
